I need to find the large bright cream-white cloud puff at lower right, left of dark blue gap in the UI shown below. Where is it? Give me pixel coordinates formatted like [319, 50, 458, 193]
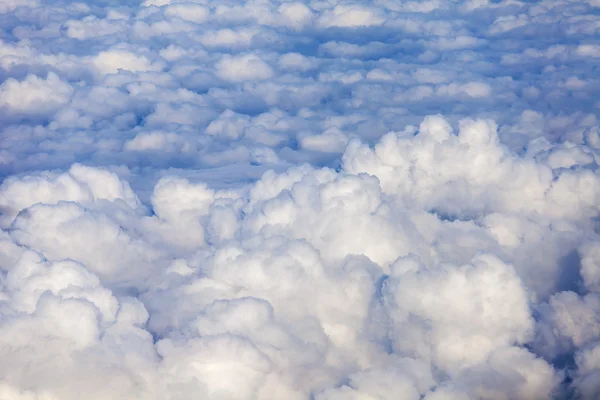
[384, 255, 533, 368]
